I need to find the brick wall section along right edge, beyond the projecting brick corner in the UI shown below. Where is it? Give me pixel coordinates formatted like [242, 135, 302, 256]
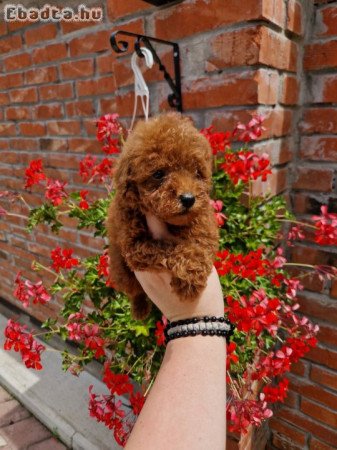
[266, 1, 337, 450]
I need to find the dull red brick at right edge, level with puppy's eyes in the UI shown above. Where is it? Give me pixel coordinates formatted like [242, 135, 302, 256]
[293, 167, 333, 192]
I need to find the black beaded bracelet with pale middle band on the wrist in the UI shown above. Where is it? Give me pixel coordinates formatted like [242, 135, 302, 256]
[165, 316, 234, 342]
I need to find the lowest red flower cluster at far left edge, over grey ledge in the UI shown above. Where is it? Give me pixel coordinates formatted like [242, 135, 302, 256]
[4, 319, 46, 370]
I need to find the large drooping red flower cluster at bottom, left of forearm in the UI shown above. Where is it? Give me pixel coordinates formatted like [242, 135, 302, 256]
[89, 362, 145, 447]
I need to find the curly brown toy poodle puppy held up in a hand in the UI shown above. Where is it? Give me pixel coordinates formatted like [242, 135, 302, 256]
[107, 113, 218, 319]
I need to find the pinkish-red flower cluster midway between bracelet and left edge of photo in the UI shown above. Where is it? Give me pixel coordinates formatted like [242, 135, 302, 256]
[66, 313, 105, 358]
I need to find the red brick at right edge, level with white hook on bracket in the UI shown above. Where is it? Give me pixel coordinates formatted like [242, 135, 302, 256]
[303, 40, 337, 70]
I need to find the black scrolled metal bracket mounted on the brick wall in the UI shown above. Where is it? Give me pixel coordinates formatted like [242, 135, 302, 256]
[110, 30, 183, 112]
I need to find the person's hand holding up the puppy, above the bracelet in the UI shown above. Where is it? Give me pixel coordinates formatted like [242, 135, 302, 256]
[135, 215, 224, 321]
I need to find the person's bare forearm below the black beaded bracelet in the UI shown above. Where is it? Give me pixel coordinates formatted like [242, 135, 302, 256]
[126, 335, 226, 450]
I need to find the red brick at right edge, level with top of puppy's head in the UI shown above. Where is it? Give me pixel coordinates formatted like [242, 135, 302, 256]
[300, 108, 337, 134]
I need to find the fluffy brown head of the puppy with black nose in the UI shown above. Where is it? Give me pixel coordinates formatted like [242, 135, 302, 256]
[115, 113, 212, 225]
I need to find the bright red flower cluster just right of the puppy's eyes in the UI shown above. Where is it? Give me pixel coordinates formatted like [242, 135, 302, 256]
[220, 150, 271, 184]
